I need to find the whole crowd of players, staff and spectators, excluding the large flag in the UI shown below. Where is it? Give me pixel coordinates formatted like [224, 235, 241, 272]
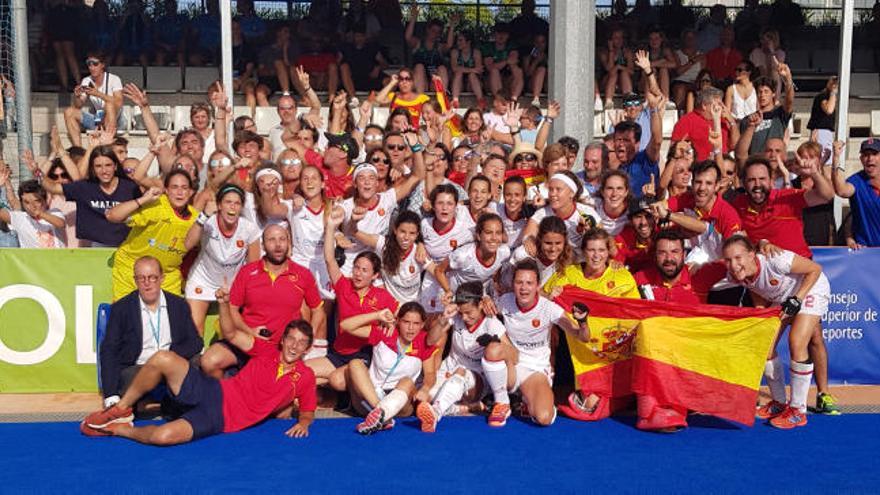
[0, 0, 880, 444]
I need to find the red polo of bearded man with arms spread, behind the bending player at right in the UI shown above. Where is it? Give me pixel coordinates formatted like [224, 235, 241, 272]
[733, 189, 813, 258]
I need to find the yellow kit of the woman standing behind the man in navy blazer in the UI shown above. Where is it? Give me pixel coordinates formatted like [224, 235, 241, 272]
[113, 194, 198, 301]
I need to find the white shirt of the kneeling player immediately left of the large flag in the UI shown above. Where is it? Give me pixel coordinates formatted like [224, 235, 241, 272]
[498, 293, 565, 371]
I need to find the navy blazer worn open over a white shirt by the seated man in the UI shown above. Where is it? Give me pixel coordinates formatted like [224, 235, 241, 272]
[98, 290, 204, 397]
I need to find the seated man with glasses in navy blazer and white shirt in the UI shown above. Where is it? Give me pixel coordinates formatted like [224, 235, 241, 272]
[98, 256, 204, 407]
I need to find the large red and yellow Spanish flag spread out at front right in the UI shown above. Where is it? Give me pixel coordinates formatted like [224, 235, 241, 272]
[556, 286, 780, 426]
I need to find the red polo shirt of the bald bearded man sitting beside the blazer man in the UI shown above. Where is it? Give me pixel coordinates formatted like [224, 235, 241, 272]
[229, 260, 322, 344]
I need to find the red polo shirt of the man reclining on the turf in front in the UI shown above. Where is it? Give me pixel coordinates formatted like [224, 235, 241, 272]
[220, 339, 318, 433]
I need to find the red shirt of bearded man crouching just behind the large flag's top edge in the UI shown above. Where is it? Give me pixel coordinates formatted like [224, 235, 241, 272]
[634, 261, 727, 304]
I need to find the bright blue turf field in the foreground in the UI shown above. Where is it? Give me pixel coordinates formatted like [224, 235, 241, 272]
[0, 414, 880, 493]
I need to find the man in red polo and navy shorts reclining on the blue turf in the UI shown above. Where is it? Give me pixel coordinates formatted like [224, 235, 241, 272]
[80, 289, 317, 445]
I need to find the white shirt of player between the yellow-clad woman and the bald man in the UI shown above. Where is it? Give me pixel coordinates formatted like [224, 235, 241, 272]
[186, 215, 261, 301]
